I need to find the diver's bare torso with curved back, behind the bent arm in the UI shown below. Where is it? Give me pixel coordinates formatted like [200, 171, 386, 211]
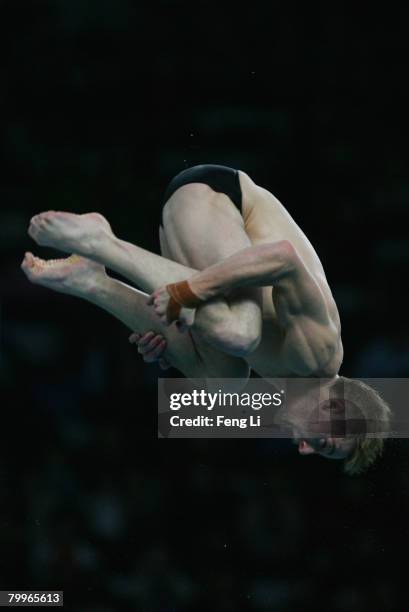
[239, 172, 343, 378]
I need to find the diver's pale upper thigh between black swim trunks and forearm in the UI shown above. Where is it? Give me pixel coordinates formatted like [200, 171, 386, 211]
[161, 183, 251, 270]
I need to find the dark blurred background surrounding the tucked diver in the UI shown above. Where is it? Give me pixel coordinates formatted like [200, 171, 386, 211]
[0, 0, 409, 612]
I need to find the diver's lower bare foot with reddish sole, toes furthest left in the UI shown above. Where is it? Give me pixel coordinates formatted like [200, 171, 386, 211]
[21, 253, 107, 297]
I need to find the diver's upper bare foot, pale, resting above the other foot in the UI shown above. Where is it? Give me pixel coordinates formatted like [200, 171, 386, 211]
[28, 210, 112, 257]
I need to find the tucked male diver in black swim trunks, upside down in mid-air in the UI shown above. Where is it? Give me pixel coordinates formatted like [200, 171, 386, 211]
[22, 165, 389, 473]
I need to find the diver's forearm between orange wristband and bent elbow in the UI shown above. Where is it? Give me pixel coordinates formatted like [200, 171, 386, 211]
[189, 241, 294, 301]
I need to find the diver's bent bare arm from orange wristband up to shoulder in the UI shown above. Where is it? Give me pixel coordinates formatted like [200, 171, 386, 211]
[189, 241, 342, 376]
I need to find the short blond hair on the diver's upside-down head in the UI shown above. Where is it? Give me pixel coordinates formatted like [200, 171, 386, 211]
[333, 376, 391, 476]
